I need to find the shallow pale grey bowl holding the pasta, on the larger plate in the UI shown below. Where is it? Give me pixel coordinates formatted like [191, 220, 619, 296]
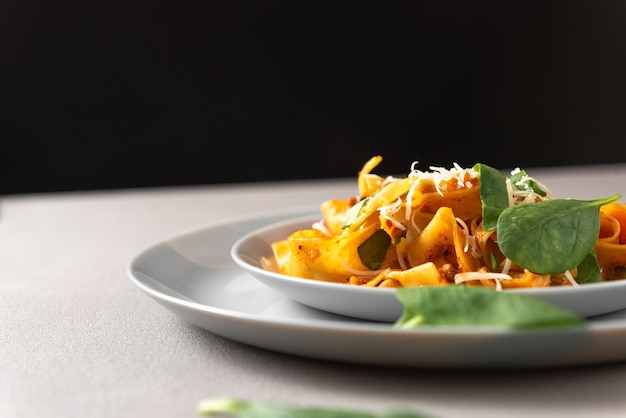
[231, 215, 626, 322]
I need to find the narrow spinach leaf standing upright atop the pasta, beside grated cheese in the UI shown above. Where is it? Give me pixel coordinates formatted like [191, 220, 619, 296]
[474, 163, 509, 231]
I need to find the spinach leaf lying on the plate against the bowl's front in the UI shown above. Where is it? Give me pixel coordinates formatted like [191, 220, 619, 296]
[394, 285, 587, 328]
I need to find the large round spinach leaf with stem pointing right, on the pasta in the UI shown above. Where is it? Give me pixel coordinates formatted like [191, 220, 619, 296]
[497, 195, 620, 274]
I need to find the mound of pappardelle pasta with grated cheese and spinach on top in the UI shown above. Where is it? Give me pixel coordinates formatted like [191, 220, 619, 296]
[264, 156, 626, 290]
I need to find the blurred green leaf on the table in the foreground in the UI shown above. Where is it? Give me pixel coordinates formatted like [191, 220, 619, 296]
[196, 398, 427, 418]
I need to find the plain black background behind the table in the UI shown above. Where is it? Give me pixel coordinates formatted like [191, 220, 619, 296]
[0, 0, 626, 194]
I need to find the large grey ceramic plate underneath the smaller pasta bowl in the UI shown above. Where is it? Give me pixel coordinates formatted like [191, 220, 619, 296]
[127, 208, 626, 369]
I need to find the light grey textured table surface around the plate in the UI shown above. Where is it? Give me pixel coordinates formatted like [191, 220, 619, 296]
[0, 164, 626, 418]
